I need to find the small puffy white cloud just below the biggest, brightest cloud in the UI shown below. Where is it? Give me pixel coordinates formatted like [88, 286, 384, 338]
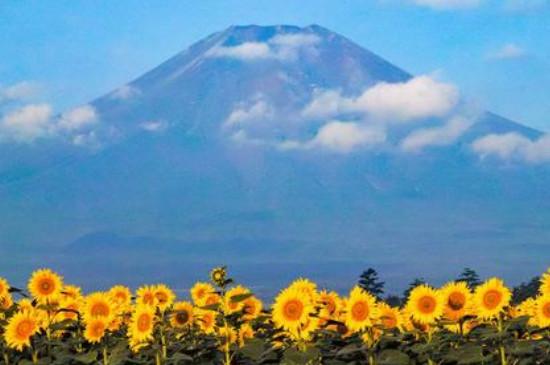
[309, 121, 386, 153]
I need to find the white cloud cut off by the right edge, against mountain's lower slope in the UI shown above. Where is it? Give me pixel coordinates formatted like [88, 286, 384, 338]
[472, 133, 550, 163]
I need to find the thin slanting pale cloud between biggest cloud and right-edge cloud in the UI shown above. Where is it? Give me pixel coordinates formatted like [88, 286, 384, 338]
[400, 116, 473, 151]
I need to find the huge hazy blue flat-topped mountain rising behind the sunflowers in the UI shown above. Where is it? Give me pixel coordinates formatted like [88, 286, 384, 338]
[0, 26, 550, 294]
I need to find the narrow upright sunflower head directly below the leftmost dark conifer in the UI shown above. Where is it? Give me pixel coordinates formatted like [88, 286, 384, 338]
[345, 286, 376, 331]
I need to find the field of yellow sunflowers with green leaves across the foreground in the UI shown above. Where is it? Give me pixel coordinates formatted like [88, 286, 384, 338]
[0, 268, 550, 365]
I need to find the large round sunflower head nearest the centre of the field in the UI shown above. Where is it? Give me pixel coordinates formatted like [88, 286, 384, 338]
[272, 288, 313, 331]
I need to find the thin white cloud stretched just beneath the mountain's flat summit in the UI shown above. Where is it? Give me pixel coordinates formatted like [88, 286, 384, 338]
[206, 34, 320, 61]
